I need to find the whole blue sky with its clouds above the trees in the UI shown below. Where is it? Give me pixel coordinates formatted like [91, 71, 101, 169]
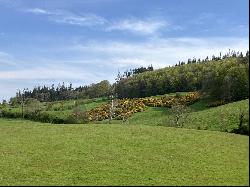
[0, 0, 249, 101]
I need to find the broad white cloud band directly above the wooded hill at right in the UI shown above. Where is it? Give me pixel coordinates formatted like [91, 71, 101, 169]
[70, 38, 248, 68]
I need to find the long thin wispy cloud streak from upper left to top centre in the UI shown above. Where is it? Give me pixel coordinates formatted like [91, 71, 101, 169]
[25, 8, 169, 35]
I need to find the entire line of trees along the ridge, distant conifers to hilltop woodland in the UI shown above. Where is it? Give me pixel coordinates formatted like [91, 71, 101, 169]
[4, 50, 249, 105]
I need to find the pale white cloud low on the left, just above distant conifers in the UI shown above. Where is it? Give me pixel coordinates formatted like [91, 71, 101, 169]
[0, 57, 114, 101]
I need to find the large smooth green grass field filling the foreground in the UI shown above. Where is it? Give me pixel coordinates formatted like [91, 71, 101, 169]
[0, 119, 249, 185]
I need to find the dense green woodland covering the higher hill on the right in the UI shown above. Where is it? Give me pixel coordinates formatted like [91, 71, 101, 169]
[115, 51, 249, 101]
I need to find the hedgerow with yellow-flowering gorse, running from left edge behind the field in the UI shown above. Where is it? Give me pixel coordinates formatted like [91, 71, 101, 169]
[1, 92, 200, 124]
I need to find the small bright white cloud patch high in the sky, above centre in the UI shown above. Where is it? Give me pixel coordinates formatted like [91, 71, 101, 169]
[106, 18, 168, 34]
